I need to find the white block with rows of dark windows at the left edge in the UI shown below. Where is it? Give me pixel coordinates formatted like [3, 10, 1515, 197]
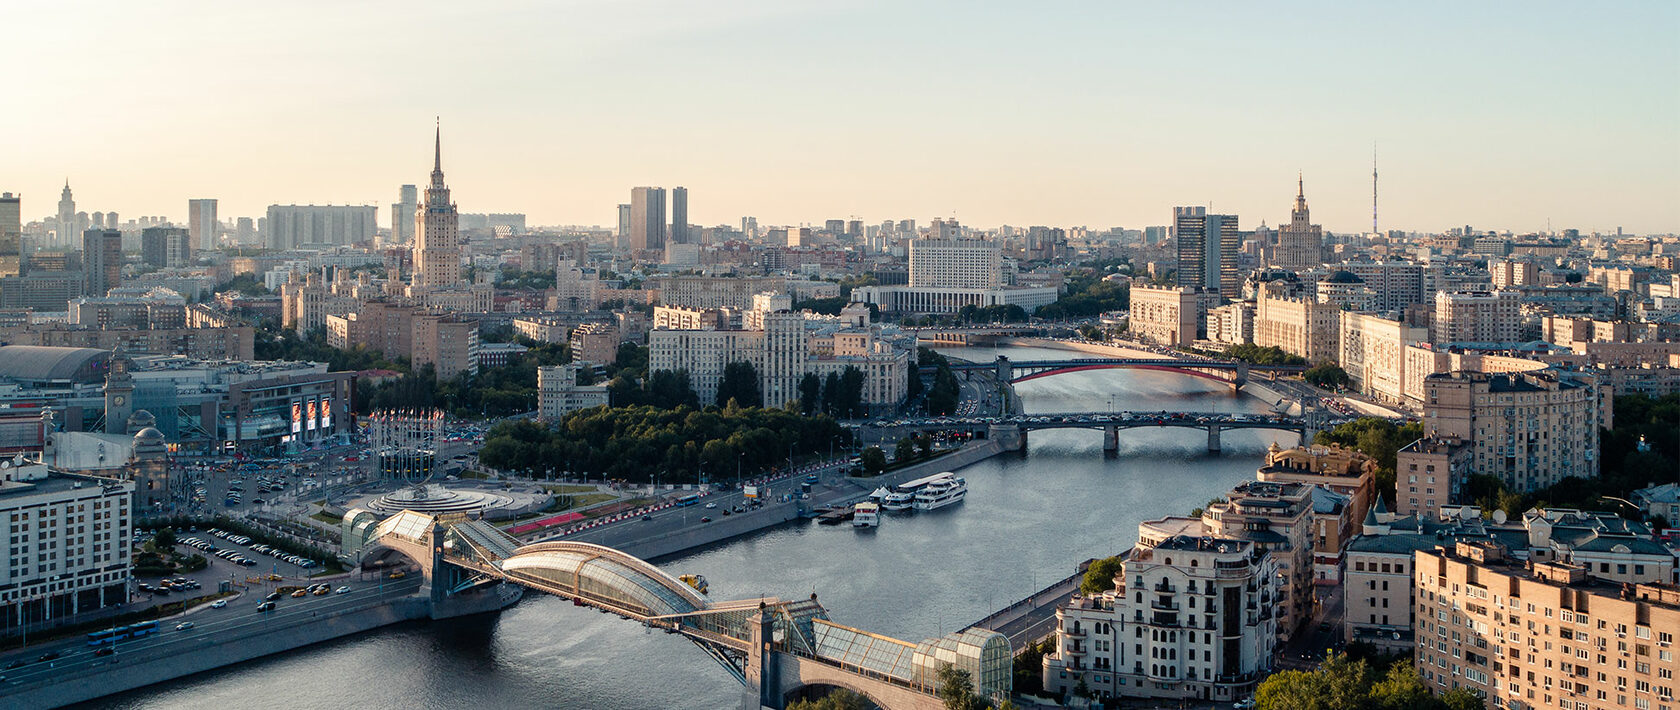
[0, 458, 134, 636]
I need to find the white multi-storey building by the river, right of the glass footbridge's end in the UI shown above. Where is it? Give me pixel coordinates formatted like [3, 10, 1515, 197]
[1043, 522, 1278, 702]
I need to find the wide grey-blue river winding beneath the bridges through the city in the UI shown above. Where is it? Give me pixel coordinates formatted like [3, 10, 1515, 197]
[87, 347, 1295, 710]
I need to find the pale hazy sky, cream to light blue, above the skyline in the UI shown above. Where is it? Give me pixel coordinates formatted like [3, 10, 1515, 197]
[0, 0, 1680, 232]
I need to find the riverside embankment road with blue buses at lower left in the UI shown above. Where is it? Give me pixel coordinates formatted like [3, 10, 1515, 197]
[0, 576, 422, 691]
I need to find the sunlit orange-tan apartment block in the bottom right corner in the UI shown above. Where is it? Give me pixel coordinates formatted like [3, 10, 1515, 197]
[1413, 542, 1680, 710]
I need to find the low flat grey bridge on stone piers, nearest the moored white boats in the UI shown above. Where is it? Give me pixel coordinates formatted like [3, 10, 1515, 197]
[853, 408, 1354, 452]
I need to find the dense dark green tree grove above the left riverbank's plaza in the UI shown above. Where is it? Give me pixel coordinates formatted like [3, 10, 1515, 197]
[479, 402, 852, 483]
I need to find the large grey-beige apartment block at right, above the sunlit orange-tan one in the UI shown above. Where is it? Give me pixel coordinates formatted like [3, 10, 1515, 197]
[1423, 371, 1609, 492]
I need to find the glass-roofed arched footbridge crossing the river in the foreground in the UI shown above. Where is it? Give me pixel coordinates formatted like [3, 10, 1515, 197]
[343, 510, 1013, 710]
